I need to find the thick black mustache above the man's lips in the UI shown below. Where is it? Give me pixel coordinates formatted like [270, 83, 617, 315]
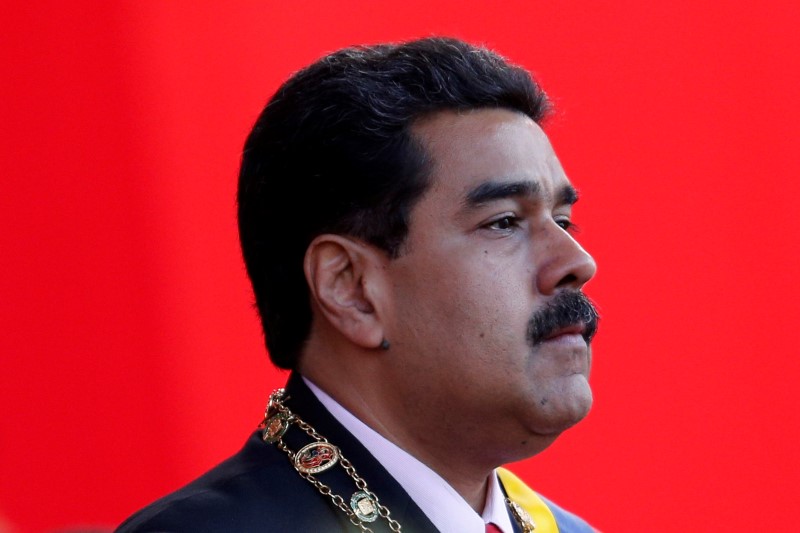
[526, 291, 600, 346]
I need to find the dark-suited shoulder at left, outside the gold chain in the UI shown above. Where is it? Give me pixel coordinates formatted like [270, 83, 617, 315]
[117, 435, 340, 533]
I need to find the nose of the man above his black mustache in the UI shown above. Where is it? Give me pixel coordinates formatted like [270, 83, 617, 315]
[536, 228, 597, 294]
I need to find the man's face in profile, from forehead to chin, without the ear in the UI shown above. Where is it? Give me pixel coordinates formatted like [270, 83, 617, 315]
[386, 109, 596, 453]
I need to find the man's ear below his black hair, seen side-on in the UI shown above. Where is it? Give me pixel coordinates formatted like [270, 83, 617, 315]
[303, 234, 384, 348]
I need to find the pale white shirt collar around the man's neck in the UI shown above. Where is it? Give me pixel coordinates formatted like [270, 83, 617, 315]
[303, 377, 513, 533]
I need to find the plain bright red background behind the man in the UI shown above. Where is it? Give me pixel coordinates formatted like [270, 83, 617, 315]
[0, 0, 800, 532]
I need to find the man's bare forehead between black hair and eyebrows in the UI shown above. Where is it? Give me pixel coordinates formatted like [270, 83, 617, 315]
[412, 109, 569, 208]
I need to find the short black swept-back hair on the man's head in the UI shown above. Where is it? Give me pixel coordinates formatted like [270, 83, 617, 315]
[238, 37, 550, 368]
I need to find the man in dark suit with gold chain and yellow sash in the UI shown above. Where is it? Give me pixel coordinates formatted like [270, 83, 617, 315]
[115, 38, 597, 533]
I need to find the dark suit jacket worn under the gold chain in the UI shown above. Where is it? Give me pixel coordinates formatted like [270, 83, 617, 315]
[117, 374, 591, 533]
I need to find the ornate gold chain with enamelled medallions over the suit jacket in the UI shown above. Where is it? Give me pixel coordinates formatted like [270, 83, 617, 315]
[258, 389, 536, 533]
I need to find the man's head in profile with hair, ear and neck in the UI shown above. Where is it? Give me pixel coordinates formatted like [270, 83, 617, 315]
[234, 39, 597, 458]
